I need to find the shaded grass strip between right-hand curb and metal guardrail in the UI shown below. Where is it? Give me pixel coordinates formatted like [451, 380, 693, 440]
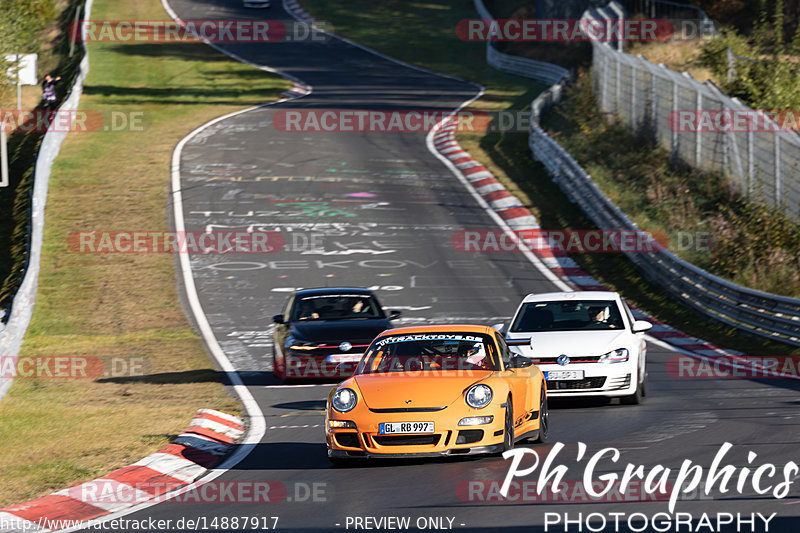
[301, 0, 794, 355]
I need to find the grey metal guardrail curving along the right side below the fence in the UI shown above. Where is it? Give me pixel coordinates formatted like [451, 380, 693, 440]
[529, 3, 800, 346]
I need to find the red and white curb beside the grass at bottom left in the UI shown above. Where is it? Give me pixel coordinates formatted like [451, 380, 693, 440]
[0, 409, 244, 533]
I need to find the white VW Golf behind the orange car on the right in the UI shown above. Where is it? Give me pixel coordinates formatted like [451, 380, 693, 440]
[504, 291, 652, 404]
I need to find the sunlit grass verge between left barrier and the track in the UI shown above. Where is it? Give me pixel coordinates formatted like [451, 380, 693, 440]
[0, 0, 290, 506]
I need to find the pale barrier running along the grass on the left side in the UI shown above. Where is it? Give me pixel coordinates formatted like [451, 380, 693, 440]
[0, 0, 93, 398]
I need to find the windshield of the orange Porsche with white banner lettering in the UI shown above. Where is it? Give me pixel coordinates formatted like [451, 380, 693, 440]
[356, 332, 500, 374]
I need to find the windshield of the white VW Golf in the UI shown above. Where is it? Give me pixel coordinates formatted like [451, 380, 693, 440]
[509, 300, 625, 332]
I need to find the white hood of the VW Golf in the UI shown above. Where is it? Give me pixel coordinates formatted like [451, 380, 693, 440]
[509, 330, 629, 358]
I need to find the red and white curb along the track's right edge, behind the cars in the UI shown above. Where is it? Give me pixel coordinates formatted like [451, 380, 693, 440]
[433, 118, 780, 370]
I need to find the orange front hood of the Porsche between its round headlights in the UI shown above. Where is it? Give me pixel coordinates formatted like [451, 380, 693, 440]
[354, 370, 492, 409]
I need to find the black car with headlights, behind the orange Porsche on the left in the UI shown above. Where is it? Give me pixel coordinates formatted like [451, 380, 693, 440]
[272, 287, 400, 380]
